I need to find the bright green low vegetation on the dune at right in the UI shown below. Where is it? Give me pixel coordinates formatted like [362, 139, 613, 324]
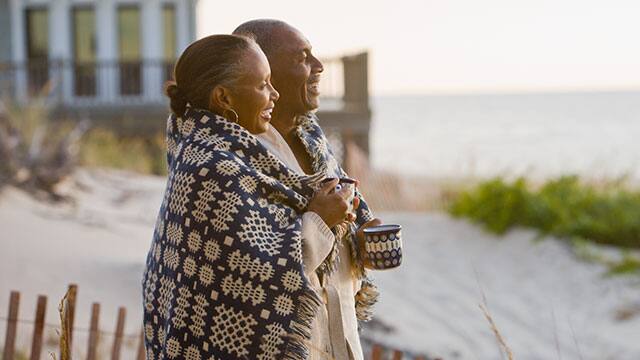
[448, 176, 640, 273]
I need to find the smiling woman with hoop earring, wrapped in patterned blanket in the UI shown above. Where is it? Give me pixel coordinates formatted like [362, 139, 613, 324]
[143, 35, 354, 360]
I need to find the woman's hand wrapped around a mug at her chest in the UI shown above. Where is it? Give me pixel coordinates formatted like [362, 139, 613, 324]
[307, 179, 355, 228]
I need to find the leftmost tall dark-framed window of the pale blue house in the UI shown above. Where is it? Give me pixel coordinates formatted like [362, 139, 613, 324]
[25, 8, 49, 95]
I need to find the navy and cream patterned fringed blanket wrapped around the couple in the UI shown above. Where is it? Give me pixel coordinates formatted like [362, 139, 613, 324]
[143, 109, 378, 360]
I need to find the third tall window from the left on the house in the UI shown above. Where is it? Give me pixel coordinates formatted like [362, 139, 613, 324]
[118, 6, 142, 95]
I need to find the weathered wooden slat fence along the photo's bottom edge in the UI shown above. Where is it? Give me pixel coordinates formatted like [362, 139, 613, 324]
[0, 284, 438, 360]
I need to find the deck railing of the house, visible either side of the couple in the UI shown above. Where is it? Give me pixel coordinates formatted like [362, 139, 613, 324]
[0, 53, 369, 110]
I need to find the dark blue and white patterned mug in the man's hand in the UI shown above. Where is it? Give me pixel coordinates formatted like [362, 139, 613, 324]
[364, 225, 402, 270]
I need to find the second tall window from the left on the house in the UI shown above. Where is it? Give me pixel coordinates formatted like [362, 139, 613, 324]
[73, 7, 96, 96]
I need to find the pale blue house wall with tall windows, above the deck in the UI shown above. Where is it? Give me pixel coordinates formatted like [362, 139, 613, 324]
[0, 0, 196, 119]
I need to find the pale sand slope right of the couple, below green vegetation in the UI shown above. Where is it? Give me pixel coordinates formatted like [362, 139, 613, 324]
[365, 213, 640, 360]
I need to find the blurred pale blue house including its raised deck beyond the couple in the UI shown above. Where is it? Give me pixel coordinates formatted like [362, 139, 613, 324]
[0, 0, 371, 156]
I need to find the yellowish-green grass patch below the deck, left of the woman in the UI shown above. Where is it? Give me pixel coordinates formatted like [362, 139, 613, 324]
[80, 128, 167, 175]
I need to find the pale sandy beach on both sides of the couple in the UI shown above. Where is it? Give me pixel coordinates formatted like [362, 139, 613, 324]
[0, 170, 640, 360]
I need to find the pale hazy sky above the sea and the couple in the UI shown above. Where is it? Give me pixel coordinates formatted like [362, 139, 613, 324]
[197, 0, 640, 95]
